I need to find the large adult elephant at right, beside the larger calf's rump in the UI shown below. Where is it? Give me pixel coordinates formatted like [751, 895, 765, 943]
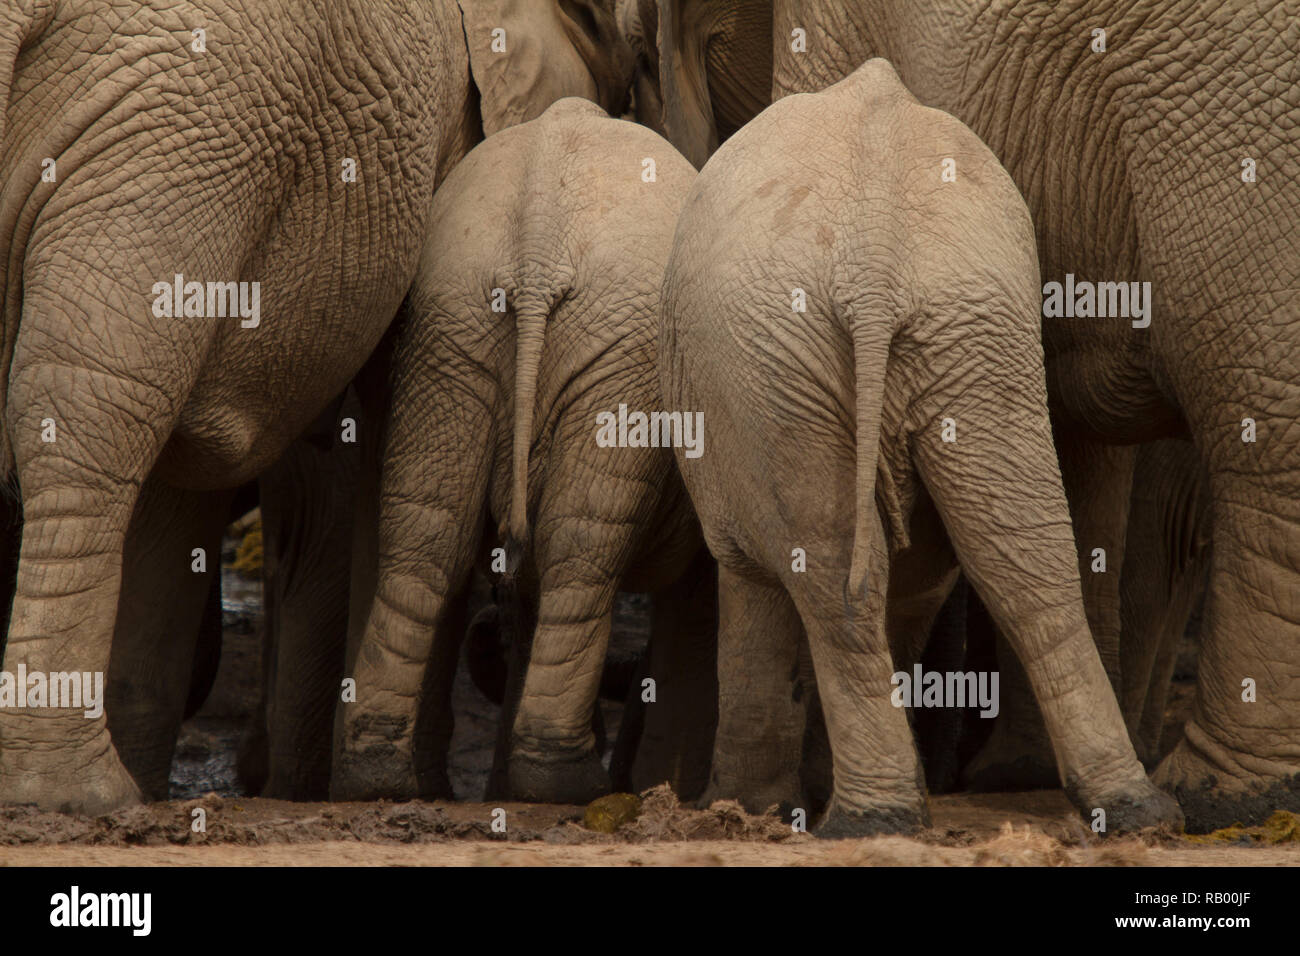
[772, 0, 1300, 830]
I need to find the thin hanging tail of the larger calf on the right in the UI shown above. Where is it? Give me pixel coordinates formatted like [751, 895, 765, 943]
[845, 304, 901, 604]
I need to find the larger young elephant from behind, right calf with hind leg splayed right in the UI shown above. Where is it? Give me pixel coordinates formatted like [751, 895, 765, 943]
[660, 60, 1180, 835]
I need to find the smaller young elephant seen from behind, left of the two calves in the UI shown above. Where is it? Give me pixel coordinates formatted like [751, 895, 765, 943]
[332, 99, 712, 803]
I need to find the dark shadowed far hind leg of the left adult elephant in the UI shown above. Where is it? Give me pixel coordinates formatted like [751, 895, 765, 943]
[107, 477, 233, 800]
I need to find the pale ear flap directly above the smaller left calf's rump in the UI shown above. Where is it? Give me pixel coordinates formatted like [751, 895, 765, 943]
[459, 0, 634, 135]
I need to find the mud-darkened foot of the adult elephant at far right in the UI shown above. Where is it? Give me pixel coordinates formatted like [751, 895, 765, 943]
[1152, 739, 1300, 834]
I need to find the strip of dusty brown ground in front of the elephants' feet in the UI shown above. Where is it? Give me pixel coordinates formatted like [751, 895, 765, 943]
[0, 791, 1300, 866]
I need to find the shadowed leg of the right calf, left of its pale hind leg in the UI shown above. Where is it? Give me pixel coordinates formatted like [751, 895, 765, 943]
[699, 564, 805, 813]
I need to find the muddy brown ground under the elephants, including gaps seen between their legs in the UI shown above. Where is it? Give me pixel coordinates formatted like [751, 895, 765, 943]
[0, 546, 1300, 866]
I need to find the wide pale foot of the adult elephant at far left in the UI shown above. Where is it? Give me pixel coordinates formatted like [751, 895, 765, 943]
[0, 711, 142, 817]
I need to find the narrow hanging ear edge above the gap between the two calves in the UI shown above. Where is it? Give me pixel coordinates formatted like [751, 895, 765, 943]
[657, 0, 718, 169]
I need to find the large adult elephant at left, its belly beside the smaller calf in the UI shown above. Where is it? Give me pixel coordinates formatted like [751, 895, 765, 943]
[0, 0, 627, 812]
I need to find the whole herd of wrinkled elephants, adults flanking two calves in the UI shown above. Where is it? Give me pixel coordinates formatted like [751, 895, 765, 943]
[0, 0, 1300, 836]
